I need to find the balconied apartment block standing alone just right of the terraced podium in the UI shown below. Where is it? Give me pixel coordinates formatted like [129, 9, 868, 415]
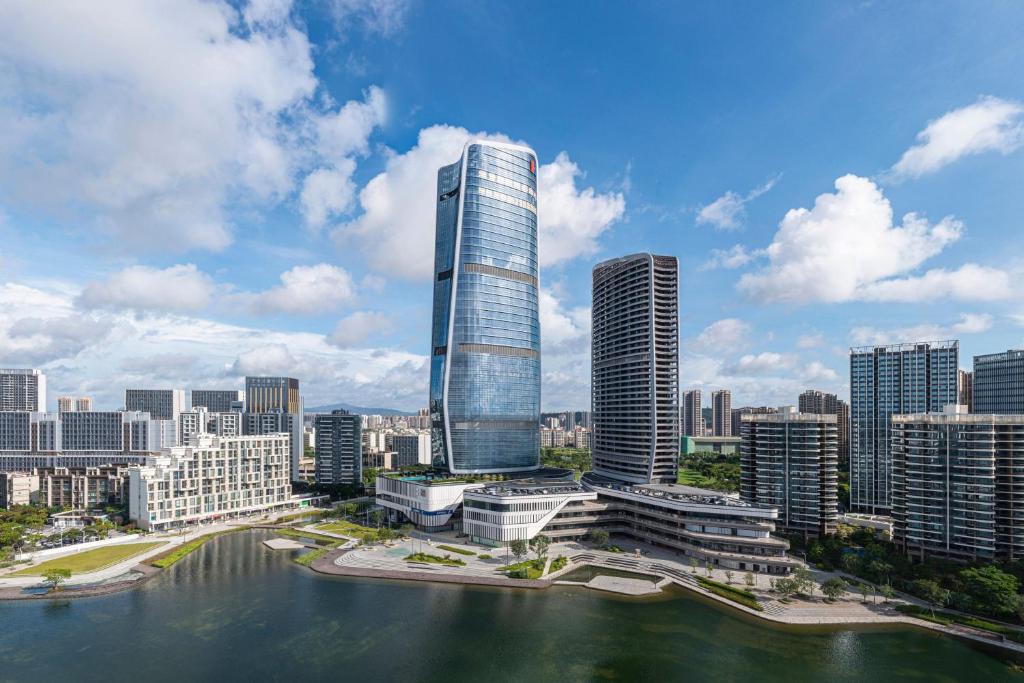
[739, 408, 839, 537]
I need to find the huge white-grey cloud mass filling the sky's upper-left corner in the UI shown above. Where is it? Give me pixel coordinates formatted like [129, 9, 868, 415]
[0, 0, 384, 251]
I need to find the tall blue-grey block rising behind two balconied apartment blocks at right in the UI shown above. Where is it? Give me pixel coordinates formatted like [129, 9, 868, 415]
[850, 341, 959, 514]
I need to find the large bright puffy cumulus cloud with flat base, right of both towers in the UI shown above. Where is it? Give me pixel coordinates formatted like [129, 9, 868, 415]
[738, 175, 1010, 303]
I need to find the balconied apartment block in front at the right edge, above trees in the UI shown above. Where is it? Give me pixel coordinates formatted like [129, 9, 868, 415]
[892, 405, 1024, 562]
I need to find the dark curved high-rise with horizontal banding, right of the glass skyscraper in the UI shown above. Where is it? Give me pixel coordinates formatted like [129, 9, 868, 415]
[591, 254, 680, 483]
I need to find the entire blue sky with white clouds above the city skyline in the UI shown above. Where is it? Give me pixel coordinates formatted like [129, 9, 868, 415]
[0, 0, 1024, 410]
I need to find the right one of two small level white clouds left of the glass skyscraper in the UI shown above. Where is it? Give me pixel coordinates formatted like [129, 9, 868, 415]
[246, 263, 355, 314]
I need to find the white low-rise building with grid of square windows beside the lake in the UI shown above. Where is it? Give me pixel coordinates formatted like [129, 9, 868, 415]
[128, 433, 293, 530]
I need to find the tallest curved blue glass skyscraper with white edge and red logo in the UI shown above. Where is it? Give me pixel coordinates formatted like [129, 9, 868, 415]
[430, 140, 541, 473]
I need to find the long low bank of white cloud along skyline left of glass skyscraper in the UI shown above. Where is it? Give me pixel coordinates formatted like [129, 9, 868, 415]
[0, 283, 428, 410]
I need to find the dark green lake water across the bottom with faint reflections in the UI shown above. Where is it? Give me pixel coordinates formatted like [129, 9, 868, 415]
[0, 531, 1024, 683]
